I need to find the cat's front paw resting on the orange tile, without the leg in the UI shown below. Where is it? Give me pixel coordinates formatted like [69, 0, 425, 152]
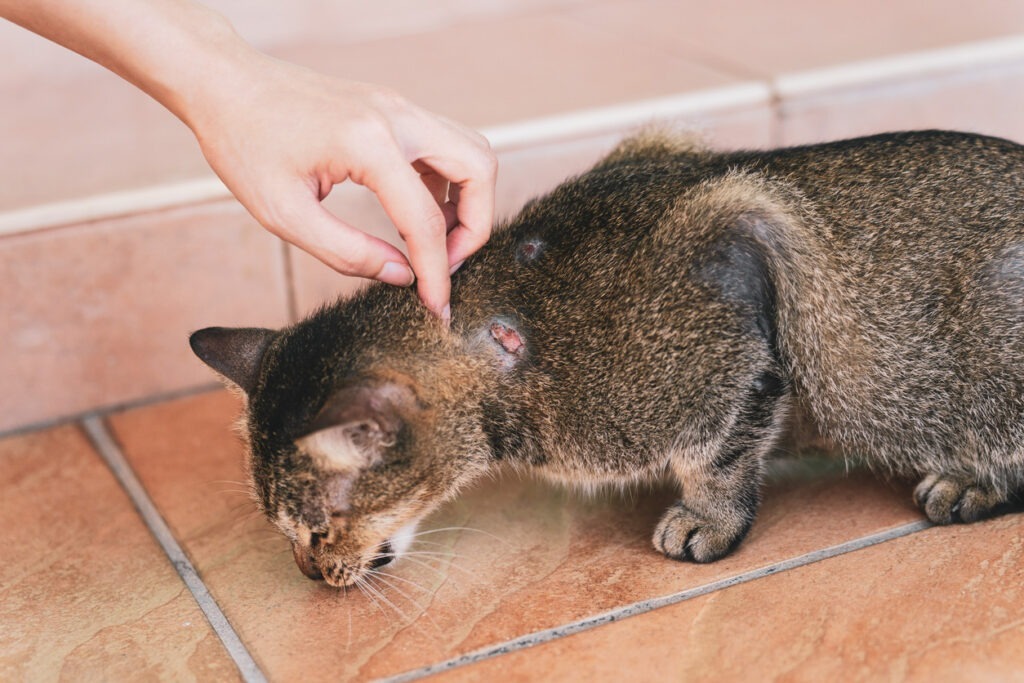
[653, 503, 750, 563]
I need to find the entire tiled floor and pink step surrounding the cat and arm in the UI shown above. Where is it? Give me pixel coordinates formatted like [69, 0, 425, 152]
[6, 0, 1024, 681]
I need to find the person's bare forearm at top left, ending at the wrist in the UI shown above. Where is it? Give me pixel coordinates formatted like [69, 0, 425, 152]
[0, 0, 254, 128]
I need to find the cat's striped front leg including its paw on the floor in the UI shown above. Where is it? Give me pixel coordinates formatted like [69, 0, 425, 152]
[653, 373, 787, 562]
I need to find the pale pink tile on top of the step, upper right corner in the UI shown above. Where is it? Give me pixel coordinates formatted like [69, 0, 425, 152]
[565, 0, 1024, 77]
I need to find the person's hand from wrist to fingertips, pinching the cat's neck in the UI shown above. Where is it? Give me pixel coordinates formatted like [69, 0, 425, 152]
[191, 51, 497, 321]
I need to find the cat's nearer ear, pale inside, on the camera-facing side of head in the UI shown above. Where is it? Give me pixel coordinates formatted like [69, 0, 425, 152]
[296, 382, 419, 471]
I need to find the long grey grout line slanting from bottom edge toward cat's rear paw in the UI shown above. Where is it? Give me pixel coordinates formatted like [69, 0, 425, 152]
[380, 519, 932, 683]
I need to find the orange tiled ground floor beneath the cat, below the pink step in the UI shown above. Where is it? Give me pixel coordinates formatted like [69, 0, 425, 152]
[8, 391, 1024, 681]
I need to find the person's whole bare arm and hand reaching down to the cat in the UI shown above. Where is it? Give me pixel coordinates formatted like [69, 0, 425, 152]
[0, 0, 497, 319]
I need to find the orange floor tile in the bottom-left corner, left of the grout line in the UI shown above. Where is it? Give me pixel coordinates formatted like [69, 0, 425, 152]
[0, 427, 238, 681]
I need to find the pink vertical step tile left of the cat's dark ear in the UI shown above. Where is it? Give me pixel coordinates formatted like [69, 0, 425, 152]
[0, 202, 288, 430]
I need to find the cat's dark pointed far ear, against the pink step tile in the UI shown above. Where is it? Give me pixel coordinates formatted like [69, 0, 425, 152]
[188, 328, 278, 393]
